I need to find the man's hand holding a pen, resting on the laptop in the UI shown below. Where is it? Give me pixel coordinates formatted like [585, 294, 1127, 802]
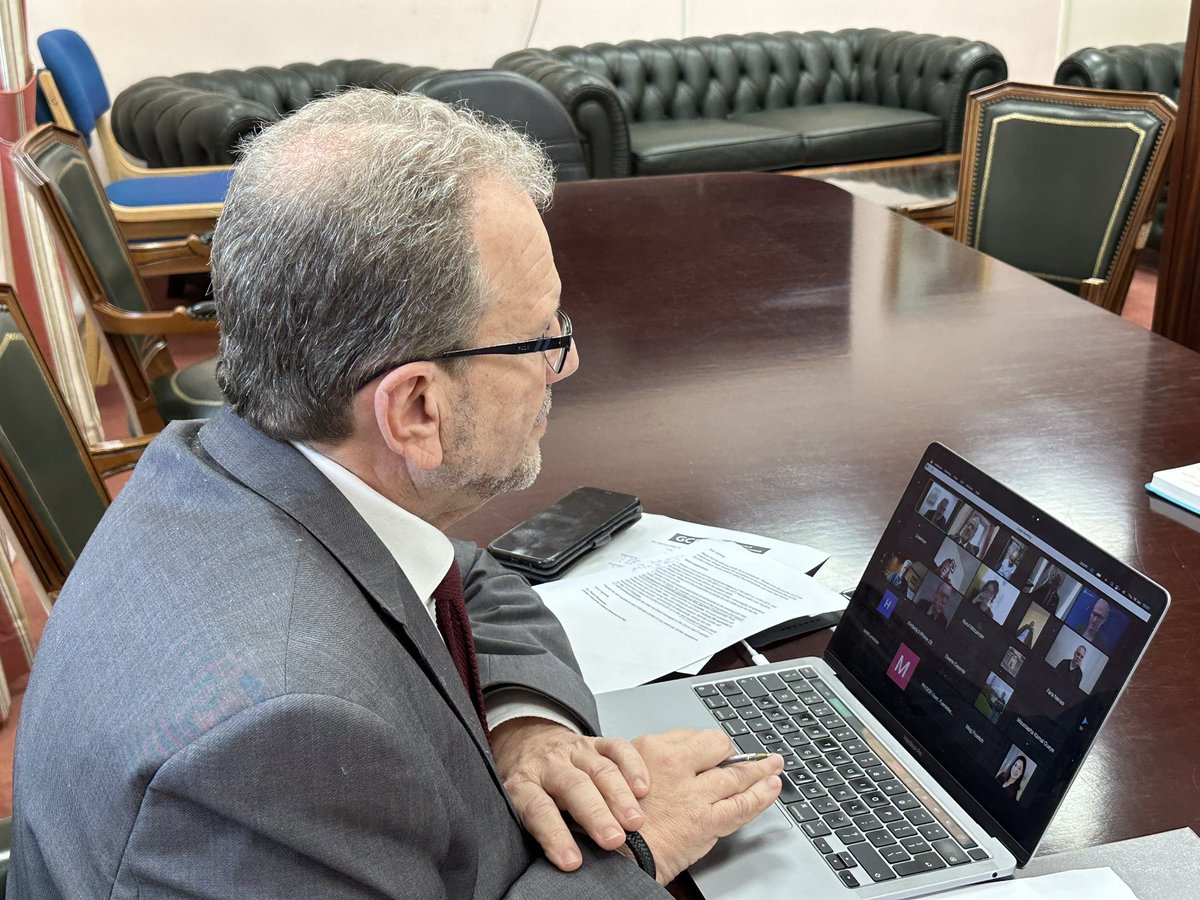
[634, 728, 784, 884]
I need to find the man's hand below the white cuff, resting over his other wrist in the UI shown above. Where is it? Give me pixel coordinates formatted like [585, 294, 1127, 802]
[492, 718, 652, 872]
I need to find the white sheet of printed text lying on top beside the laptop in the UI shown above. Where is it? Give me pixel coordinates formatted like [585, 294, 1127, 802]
[536, 540, 845, 694]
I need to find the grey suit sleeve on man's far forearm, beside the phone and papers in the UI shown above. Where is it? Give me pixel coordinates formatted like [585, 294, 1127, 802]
[455, 541, 600, 734]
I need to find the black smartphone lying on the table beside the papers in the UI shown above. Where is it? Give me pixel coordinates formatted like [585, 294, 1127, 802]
[487, 487, 642, 584]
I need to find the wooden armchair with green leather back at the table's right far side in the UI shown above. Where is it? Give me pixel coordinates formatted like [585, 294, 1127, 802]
[954, 82, 1175, 313]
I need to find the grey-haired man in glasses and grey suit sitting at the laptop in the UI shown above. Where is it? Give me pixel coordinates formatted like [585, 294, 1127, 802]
[10, 91, 782, 898]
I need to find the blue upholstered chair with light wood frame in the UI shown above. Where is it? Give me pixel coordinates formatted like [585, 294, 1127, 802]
[37, 29, 226, 240]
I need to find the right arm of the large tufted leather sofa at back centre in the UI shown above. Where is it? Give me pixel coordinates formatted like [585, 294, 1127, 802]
[838, 29, 1008, 154]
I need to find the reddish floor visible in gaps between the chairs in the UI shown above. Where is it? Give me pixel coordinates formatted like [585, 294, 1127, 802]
[0, 268, 1158, 816]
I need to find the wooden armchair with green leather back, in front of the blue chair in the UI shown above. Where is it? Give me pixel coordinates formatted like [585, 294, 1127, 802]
[13, 125, 222, 433]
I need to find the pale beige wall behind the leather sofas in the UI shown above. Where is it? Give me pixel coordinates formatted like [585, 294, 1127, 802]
[28, 0, 1188, 95]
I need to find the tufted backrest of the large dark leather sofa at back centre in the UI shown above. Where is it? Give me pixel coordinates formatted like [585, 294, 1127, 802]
[544, 29, 1004, 144]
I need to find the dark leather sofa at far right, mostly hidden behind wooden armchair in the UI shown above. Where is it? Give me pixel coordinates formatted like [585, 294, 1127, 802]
[1054, 43, 1183, 250]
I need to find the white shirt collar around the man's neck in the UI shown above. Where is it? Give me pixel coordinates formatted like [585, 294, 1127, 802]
[293, 442, 454, 606]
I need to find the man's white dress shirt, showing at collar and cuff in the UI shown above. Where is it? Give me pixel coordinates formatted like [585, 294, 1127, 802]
[293, 442, 580, 733]
